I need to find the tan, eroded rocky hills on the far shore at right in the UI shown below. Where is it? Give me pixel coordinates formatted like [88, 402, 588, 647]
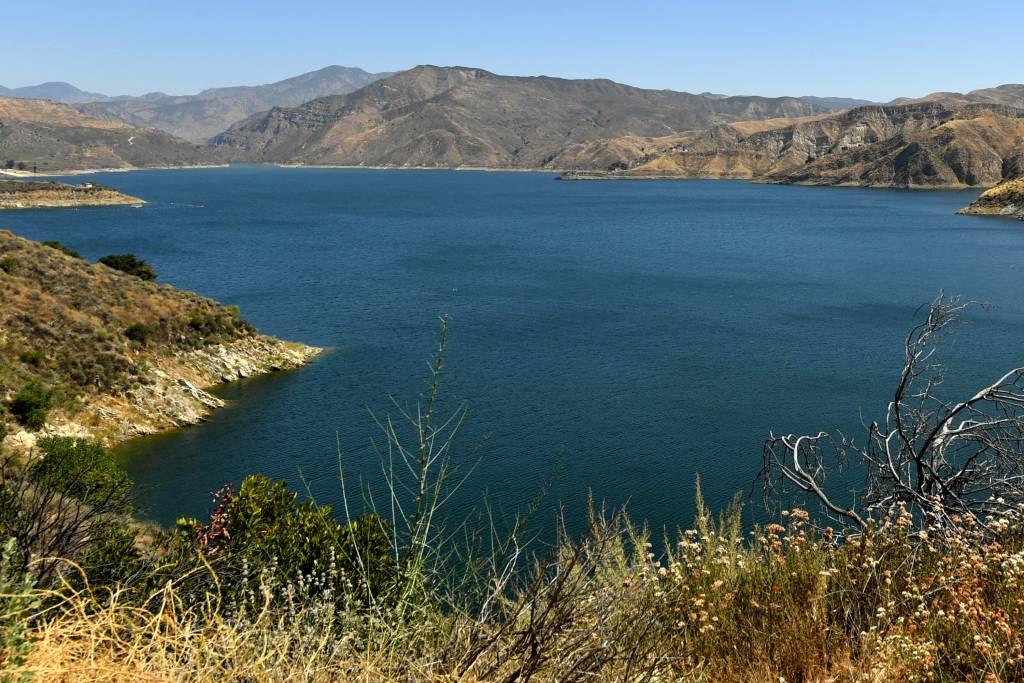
[567, 101, 1024, 187]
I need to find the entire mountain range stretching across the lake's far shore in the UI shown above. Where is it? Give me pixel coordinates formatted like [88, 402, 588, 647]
[0, 66, 1024, 186]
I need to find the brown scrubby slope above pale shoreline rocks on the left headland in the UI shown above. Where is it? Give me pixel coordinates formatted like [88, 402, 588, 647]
[0, 230, 252, 428]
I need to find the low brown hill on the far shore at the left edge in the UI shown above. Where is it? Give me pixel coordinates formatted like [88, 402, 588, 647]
[0, 97, 216, 172]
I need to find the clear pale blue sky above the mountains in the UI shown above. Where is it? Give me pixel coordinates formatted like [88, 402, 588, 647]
[8, 0, 1024, 100]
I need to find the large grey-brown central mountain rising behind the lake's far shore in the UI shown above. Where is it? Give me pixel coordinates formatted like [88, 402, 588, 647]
[211, 67, 825, 168]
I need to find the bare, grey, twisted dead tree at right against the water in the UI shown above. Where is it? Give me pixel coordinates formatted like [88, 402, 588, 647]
[761, 294, 1024, 530]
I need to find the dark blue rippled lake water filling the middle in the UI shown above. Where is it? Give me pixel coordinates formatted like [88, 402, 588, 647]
[2, 167, 1024, 528]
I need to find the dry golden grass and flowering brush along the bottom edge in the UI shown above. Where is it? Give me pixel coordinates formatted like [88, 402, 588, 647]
[10, 497, 1024, 683]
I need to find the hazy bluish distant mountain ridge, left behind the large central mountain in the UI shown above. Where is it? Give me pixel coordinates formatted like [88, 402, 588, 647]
[79, 67, 391, 142]
